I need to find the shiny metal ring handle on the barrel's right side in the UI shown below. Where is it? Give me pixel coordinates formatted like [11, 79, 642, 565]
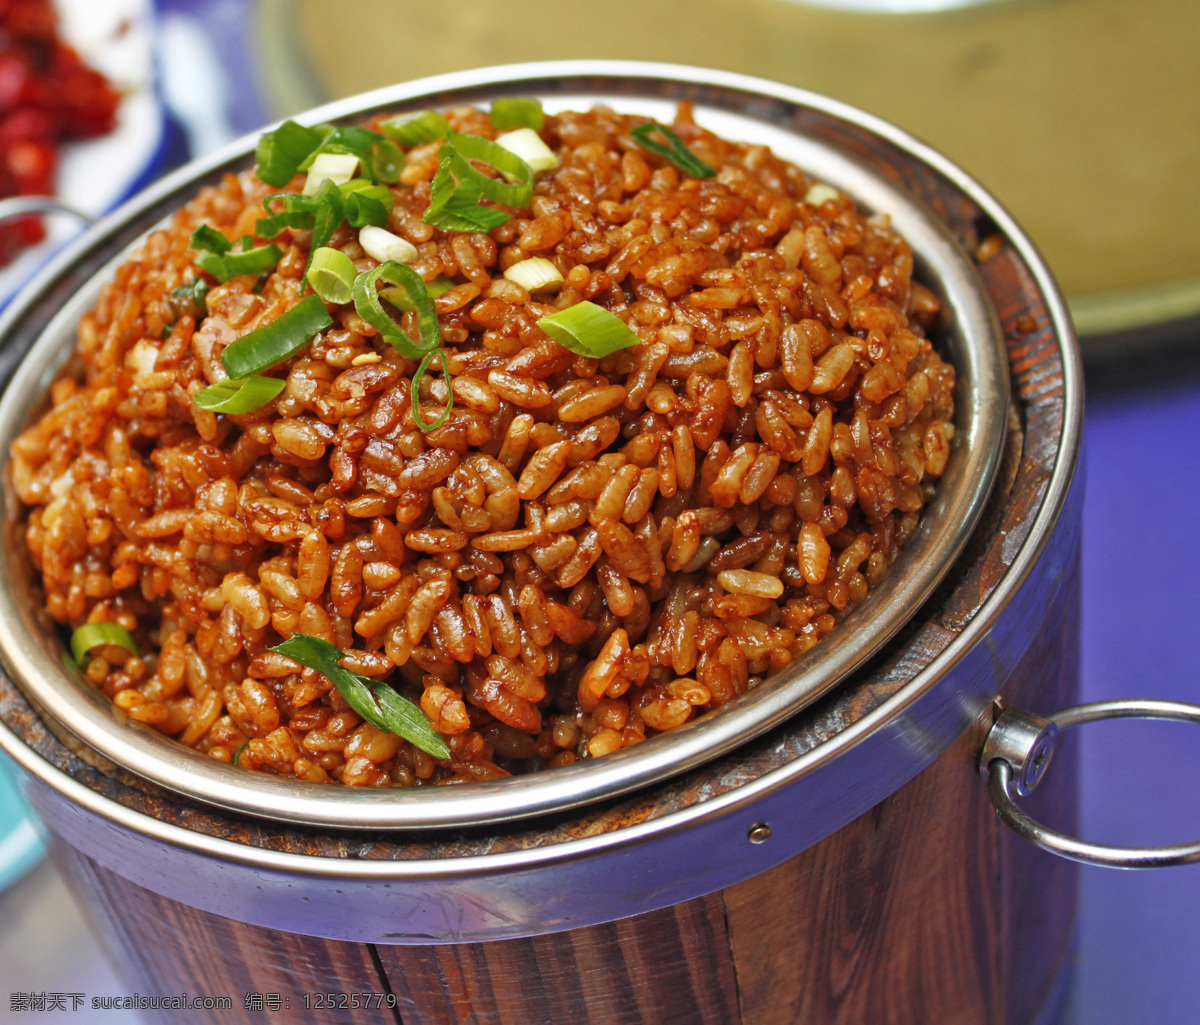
[979, 700, 1200, 869]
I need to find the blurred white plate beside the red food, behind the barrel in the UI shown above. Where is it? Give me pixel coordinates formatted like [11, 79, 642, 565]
[0, 0, 163, 308]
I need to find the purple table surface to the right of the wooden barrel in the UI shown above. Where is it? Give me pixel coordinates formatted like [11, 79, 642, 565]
[1046, 348, 1200, 1025]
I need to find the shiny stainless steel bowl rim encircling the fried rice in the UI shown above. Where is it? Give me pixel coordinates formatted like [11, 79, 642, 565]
[0, 62, 1009, 829]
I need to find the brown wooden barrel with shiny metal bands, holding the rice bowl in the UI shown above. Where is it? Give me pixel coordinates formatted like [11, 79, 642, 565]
[0, 65, 1081, 1025]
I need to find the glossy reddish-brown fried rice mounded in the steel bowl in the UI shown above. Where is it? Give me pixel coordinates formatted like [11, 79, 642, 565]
[2, 104, 954, 787]
